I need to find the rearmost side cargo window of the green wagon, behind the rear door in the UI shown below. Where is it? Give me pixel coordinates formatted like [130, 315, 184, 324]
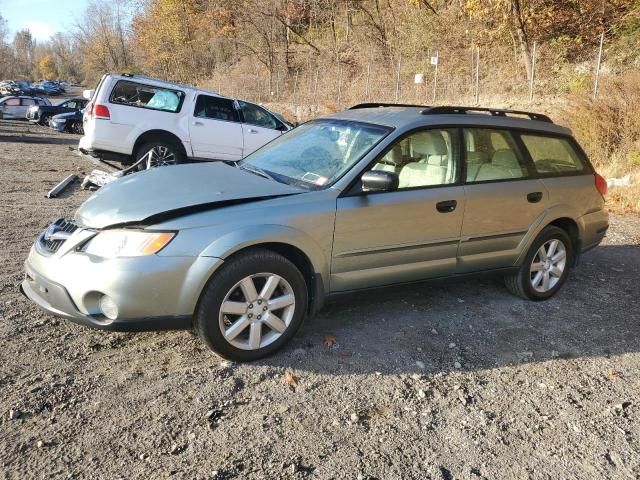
[520, 134, 585, 174]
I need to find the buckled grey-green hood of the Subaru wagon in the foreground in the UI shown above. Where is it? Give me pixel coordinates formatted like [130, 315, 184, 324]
[75, 162, 306, 228]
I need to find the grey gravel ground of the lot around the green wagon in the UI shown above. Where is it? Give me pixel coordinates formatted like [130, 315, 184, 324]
[0, 117, 640, 480]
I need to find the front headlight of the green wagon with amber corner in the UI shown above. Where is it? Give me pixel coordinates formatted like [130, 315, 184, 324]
[83, 230, 176, 258]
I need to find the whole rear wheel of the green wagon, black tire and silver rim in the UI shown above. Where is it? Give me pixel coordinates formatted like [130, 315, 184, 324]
[505, 226, 574, 301]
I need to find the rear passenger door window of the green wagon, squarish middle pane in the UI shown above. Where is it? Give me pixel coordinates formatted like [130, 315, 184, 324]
[464, 128, 529, 183]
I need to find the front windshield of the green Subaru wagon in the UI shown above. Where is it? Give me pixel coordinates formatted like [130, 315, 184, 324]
[240, 120, 391, 189]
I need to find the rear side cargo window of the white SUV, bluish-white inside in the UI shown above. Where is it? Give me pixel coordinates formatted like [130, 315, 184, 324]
[109, 80, 184, 113]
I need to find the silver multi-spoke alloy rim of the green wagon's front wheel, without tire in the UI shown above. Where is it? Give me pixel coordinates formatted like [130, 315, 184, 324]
[219, 273, 296, 350]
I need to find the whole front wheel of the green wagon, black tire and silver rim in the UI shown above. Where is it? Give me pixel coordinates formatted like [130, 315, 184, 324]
[195, 249, 309, 361]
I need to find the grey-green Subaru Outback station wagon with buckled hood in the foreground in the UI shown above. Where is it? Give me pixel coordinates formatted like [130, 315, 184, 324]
[21, 104, 608, 360]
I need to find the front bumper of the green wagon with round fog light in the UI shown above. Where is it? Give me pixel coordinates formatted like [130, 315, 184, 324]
[20, 223, 222, 331]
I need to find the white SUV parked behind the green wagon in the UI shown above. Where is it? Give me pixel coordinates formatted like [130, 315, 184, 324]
[79, 74, 292, 167]
